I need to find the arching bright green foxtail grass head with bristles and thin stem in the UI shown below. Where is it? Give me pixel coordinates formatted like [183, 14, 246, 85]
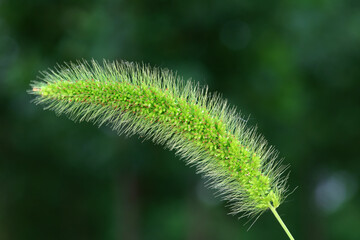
[28, 60, 293, 239]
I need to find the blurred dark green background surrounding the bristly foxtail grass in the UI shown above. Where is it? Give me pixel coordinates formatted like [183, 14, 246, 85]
[0, 0, 360, 240]
